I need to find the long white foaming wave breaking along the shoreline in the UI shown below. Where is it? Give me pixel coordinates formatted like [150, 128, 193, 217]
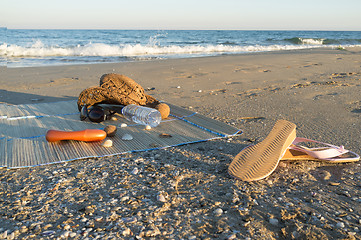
[0, 41, 338, 58]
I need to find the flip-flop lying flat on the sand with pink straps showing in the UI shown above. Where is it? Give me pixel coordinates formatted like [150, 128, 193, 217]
[281, 137, 360, 163]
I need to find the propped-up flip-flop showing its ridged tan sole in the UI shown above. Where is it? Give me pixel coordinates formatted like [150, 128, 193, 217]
[228, 120, 296, 181]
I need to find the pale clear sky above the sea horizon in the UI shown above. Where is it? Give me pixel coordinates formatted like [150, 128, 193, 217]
[0, 0, 361, 31]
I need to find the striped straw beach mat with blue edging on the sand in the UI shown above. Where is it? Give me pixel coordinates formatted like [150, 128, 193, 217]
[0, 101, 242, 168]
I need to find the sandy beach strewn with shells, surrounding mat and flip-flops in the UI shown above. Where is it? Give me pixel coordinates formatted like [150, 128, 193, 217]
[0, 48, 361, 239]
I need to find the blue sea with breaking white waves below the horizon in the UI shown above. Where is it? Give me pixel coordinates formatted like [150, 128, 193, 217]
[0, 28, 361, 68]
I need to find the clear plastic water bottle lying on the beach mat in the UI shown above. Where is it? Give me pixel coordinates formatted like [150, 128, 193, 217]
[122, 104, 162, 127]
